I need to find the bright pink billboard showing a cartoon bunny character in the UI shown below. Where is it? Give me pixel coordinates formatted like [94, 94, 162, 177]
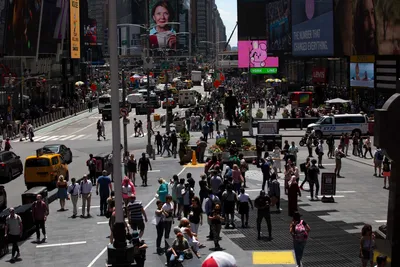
[238, 40, 279, 68]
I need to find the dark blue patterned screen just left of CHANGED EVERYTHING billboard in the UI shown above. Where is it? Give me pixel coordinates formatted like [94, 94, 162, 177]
[266, 0, 292, 51]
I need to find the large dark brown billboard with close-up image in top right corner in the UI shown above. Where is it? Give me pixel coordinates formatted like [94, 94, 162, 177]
[335, 0, 400, 56]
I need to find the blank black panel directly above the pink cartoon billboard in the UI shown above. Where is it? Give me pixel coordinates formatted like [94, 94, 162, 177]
[237, 0, 267, 40]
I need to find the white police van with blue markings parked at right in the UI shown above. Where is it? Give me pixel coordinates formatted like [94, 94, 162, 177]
[307, 114, 369, 138]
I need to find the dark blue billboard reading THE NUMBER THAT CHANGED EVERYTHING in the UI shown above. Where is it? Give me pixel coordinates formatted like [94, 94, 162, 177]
[292, 0, 334, 56]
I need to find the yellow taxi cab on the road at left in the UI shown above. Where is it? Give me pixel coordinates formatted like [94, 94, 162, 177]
[24, 149, 69, 189]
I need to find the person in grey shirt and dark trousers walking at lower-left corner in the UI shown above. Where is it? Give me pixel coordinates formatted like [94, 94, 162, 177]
[4, 208, 22, 262]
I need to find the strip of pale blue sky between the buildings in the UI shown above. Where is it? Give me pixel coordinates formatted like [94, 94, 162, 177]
[215, 0, 237, 46]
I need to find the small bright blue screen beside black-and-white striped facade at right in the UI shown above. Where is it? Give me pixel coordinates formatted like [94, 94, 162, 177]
[350, 63, 375, 88]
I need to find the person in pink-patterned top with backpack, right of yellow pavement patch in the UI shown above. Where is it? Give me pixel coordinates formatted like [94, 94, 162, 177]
[290, 211, 311, 267]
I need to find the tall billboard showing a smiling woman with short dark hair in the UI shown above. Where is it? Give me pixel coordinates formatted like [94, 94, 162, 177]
[149, 0, 178, 50]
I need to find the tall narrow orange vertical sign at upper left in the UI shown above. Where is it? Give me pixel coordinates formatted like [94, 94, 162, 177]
[69, 0, 81, 58]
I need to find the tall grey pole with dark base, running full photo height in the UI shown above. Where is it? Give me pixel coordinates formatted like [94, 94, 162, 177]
[107, 1, 133, 265]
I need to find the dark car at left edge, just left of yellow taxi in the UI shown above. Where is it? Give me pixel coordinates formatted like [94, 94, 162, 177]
[0, 151, 24, 182]
